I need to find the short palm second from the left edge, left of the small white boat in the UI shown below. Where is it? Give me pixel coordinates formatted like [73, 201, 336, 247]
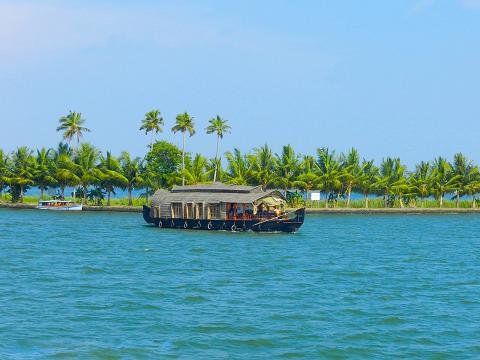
[7, 146, 35, 202]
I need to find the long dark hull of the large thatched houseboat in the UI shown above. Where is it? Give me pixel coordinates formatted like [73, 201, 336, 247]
[143, 205, 305, 233]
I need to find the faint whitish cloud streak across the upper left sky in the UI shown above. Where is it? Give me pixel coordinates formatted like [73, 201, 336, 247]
[0, 1, 272, 65]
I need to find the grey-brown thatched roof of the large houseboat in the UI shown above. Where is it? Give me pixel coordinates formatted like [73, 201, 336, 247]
[152, 183, 285, 206]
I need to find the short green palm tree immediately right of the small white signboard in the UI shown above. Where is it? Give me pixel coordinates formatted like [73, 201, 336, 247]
[316, 148, 342, 208]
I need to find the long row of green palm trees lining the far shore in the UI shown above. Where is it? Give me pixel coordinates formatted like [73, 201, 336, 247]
[0, 110, 480, 208]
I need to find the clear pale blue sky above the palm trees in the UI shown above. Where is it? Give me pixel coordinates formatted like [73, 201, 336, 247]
[0, 0, 480, 166]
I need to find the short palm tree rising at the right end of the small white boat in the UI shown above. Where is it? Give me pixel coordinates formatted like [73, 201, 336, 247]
[73, 144, 102, 204]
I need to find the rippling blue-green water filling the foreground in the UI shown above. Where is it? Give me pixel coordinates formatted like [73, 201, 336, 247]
[0, 209, 480, 359]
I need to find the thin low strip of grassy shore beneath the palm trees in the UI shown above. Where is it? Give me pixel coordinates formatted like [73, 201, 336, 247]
[0, 202, 480, 215]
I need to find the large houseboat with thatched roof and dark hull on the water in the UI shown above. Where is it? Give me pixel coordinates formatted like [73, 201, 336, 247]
[143, 182, 305, 232]
